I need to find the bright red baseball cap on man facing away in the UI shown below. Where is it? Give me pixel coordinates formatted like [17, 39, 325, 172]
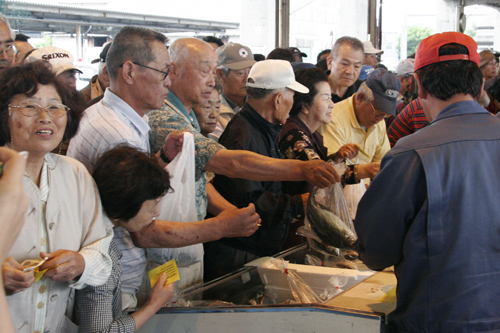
[415, 31, 481, 71]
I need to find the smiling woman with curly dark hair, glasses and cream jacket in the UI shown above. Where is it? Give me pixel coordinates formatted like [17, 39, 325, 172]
[0, 62, 112, 332]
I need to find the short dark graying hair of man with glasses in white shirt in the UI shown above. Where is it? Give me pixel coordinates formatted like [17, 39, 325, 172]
[106, 26, 168, 79]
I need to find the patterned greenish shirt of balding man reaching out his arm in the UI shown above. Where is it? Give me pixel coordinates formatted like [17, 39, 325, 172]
[148, 92, 224, 221]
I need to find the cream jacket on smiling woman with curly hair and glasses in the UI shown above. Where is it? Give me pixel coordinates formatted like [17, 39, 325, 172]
[7, 154, 112, 332]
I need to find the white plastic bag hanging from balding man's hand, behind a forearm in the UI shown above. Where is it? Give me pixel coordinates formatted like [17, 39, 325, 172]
[147, 132, 204, 290]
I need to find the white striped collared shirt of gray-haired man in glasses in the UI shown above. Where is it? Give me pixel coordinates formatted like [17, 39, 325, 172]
[67, 89, 150, 172]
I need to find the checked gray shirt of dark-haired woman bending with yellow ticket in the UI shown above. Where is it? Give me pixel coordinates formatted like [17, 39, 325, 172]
[75, 241, 135, 333]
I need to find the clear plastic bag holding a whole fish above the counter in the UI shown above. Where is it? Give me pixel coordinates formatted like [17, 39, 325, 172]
[297, 161, 357, 260]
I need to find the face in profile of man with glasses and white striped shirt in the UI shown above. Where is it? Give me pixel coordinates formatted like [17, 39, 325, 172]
[134, 41, 171, 110]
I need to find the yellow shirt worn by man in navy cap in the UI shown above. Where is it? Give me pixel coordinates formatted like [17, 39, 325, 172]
[318, 95, 390, 182]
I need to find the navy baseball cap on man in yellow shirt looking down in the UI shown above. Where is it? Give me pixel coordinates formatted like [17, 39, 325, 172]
[365, 68, 401, 116]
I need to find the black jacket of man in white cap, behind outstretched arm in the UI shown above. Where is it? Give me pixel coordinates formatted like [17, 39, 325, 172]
[210, 104, 304, 256]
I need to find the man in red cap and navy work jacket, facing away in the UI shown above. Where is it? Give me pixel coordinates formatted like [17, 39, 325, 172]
[355, 32, 500, 332]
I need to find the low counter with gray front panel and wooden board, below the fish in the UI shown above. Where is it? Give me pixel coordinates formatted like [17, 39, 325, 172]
[139, 244, 396, 333]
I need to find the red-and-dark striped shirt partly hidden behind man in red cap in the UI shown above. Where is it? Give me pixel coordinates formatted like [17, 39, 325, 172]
[387, 98, 429, 147]
